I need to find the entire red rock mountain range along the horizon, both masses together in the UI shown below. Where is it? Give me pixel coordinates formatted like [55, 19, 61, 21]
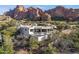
[5, 5, 79, 21]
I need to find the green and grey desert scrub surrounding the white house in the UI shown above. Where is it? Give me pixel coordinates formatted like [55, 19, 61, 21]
[0, 19, 79, 54]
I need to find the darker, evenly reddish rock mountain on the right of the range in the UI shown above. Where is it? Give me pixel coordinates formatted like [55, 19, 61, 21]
[46, 6, 79, 20]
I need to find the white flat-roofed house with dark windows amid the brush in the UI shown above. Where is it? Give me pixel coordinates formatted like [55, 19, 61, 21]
[18, 25, 56, 41]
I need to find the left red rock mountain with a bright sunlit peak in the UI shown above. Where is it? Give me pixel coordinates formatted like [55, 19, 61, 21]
[5, 5, 49, 21]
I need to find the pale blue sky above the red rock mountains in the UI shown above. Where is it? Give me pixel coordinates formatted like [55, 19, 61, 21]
[0, 5, 79, 15]
